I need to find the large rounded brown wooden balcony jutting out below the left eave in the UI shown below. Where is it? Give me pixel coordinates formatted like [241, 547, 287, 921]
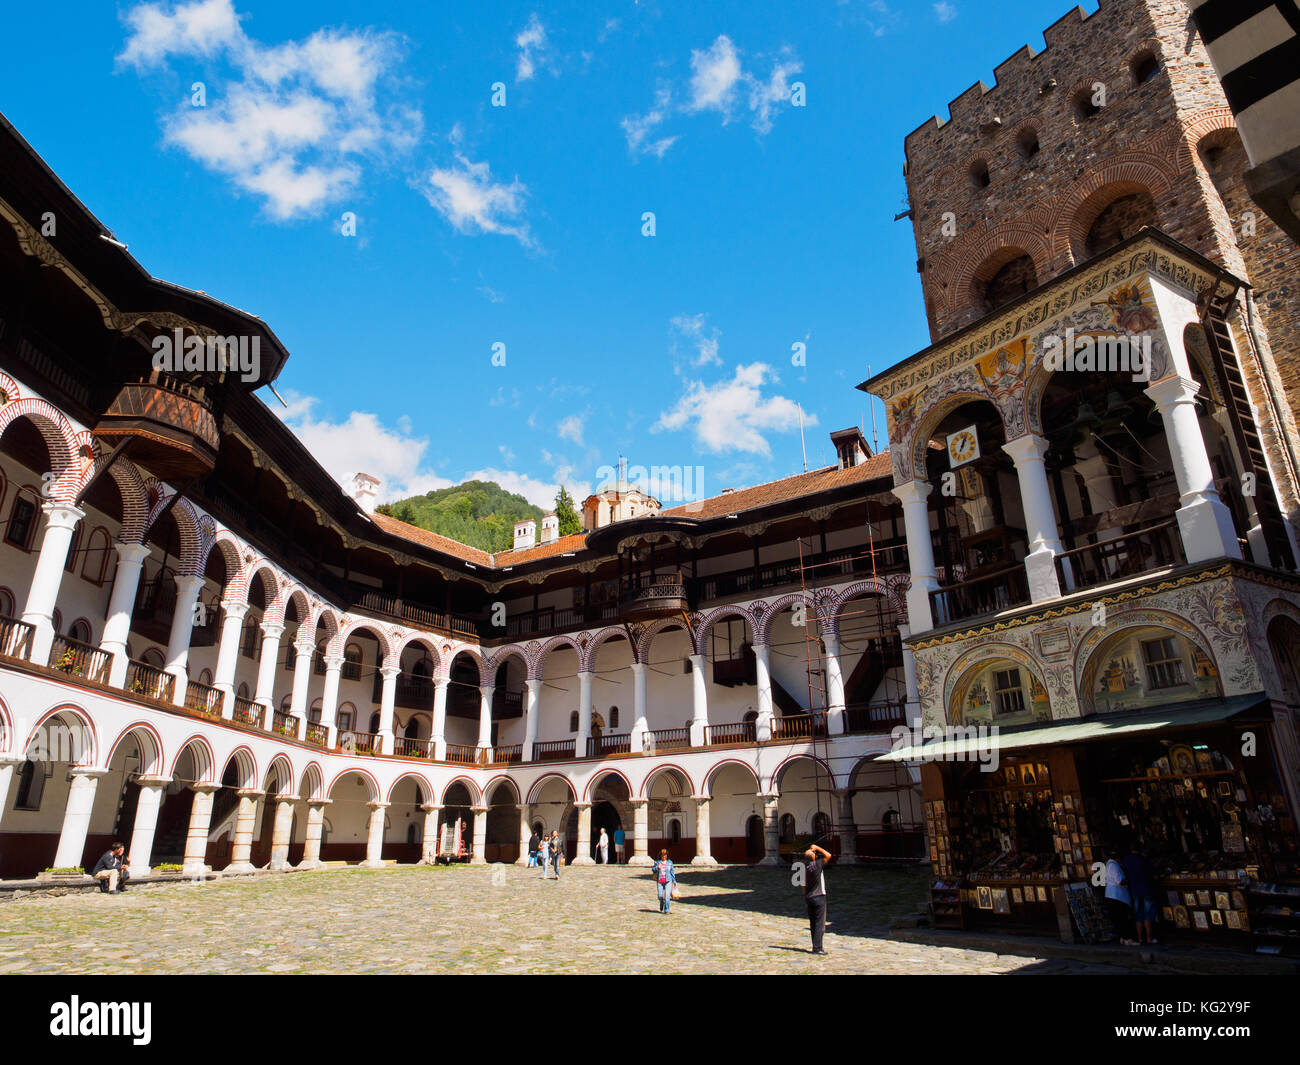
[95, 373, 221, 484]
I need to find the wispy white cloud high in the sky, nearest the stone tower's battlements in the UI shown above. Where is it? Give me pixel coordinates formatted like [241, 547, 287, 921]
[620, 34, 803, 159]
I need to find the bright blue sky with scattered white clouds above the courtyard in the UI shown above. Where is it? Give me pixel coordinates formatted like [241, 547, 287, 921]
[0, 0, 1095, 505]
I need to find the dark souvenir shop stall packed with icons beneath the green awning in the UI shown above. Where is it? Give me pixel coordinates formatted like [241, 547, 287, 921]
[909, 697, 1300, 954]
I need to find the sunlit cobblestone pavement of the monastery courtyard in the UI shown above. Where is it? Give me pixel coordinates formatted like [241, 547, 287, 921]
[0, 866, 1144, 974]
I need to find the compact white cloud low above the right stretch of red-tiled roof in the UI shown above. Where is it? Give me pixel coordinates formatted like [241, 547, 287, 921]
[650, 363, 816, 456]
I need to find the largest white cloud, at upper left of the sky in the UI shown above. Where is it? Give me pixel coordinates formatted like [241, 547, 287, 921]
[117, 0, 423, 220]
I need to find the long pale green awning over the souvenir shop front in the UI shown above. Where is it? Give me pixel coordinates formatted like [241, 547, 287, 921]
[875, 692, 1269, 762]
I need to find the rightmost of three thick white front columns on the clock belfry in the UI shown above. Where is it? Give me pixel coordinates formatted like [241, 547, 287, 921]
[1147, 376, 1242, 562]
